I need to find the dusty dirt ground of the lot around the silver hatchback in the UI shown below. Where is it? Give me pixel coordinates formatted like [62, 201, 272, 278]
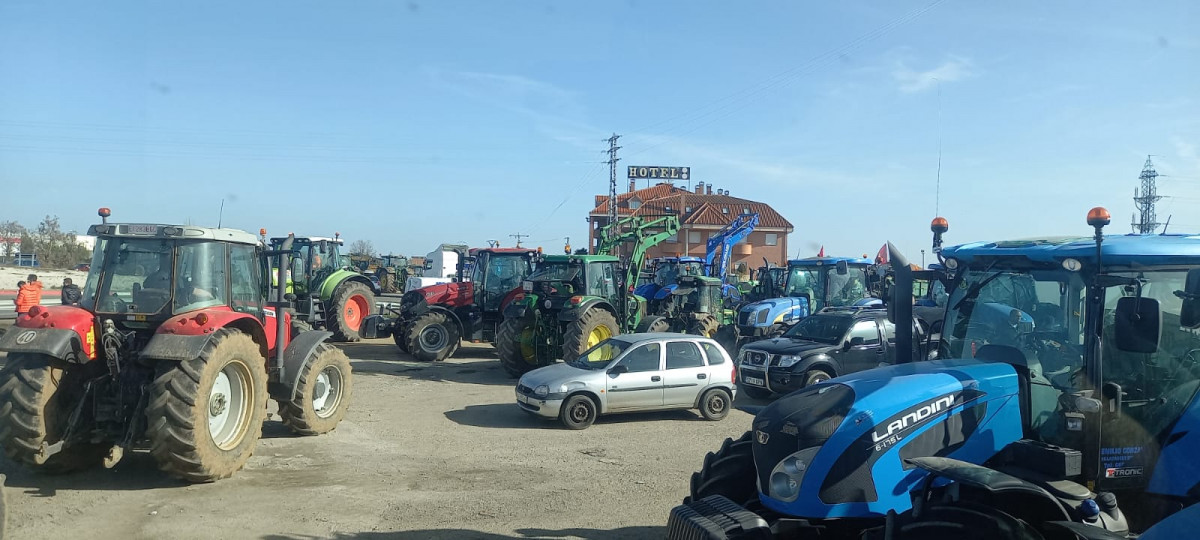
[0, 340, 761, 540]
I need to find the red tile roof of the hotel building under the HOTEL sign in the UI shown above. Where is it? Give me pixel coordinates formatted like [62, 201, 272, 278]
[592, 184, 793, 230]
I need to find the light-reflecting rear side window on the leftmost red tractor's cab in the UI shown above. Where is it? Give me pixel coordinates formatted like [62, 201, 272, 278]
[173, 242, 228, 313]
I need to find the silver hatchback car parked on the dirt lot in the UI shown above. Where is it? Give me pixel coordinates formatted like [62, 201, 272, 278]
[516, 334, 736, 430]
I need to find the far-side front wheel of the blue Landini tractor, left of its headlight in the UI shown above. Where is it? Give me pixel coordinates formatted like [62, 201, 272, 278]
[683, 431, 758, 505]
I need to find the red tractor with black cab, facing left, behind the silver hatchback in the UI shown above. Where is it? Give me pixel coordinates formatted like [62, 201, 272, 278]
[362, 247, 538, 361]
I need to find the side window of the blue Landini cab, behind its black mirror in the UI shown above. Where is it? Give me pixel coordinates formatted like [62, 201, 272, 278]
[1100, 271, 1200, 437]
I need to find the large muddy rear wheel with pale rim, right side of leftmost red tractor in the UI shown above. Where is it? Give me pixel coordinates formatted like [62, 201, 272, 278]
[146, 329, 266, 482]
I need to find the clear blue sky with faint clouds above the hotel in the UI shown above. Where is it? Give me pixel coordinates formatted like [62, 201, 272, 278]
[0, 0, 1200, 259]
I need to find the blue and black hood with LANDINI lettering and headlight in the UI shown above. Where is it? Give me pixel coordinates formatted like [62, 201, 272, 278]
[754, 359, 1021, 518]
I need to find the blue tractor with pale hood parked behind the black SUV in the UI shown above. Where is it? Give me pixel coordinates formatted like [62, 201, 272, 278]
[737, 257, 877, 343]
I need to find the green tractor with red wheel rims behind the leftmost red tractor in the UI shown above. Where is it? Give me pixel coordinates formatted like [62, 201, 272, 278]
[270, 235, 374, 341]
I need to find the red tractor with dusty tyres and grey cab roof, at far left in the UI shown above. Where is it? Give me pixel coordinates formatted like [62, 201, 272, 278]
[0, 209, 352, 482]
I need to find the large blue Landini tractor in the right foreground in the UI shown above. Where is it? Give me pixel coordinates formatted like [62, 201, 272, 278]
[668, 208, 1200, 540]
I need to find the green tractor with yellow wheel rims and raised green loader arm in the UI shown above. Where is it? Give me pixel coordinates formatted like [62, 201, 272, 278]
[496, 216, 679, 377]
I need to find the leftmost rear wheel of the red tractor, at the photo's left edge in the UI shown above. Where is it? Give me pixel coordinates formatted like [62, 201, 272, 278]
[0, 353, 108, 473]
